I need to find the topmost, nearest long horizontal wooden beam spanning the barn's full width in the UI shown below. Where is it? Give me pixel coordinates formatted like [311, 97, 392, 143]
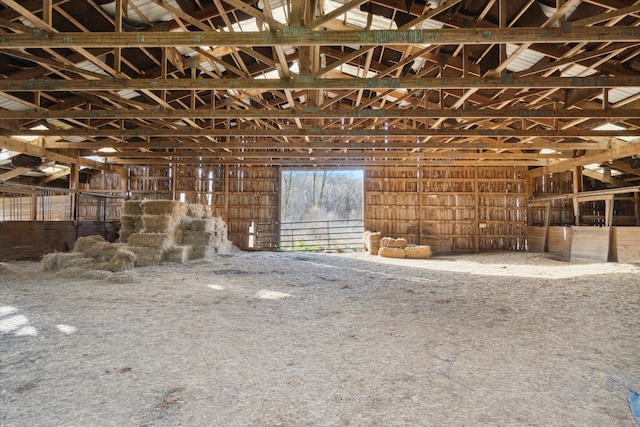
[0, 26, 640, 49]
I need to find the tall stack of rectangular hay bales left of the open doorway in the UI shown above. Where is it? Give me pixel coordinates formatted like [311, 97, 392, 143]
[120, 200, 232, 267]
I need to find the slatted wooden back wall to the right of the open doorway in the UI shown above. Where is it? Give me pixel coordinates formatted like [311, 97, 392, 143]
[364, 166, 528, 252]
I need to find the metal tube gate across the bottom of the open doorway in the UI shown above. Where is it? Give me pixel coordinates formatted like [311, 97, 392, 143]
[256, 219, 364, 251]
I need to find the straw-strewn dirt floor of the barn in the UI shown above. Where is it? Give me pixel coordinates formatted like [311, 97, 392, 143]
[0, 253, 640, 426]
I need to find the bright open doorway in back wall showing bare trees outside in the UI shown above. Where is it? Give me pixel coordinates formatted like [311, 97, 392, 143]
[279, 169, 364, 251]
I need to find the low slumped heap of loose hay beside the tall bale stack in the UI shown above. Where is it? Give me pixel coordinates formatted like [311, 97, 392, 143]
[41, 236, 136, 272]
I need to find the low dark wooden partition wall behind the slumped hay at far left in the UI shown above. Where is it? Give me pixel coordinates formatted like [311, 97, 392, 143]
[0, 221, 120, 261]
